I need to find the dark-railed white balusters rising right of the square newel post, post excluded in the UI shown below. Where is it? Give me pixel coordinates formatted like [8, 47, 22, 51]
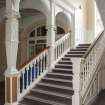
[81, 32, 105, 96]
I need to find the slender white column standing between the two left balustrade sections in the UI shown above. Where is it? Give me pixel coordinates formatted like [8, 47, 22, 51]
[47, 1, 56, 70]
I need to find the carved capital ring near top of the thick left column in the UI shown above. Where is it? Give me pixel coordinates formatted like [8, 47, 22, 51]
[5, 10, 20, 19]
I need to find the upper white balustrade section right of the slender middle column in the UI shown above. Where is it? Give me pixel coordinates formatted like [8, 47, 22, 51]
[54, 33, 71, 61]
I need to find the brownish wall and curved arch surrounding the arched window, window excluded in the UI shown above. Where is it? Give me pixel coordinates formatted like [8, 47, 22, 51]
[18, 8, 46, 65]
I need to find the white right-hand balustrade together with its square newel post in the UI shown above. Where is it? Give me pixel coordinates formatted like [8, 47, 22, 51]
[71, 31, 105, 105]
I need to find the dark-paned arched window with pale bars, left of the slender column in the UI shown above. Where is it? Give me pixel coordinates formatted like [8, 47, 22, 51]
[28, 25, 46, 58]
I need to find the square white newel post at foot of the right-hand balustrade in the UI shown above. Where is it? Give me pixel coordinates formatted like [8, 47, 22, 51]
[71, 58, 82, 105]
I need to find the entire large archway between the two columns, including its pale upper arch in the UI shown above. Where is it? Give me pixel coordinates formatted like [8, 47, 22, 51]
[17, 0, 49, 67]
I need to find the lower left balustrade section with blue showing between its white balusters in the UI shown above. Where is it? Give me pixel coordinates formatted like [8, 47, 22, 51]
[18, 48, 48, 99]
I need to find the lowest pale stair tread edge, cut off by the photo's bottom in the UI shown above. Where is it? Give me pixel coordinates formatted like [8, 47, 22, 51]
[25, 96, 66, 105]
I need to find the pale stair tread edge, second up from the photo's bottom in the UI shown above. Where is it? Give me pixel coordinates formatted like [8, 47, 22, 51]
[32, 89, 72, 99]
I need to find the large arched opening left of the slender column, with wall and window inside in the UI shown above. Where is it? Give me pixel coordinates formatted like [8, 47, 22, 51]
[17, 8, 47, 66]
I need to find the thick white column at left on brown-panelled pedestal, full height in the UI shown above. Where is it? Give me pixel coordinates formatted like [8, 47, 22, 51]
[5, 0, 20, 105]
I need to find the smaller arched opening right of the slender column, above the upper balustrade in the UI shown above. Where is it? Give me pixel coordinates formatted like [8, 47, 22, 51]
[55, 12, 71, 40]
